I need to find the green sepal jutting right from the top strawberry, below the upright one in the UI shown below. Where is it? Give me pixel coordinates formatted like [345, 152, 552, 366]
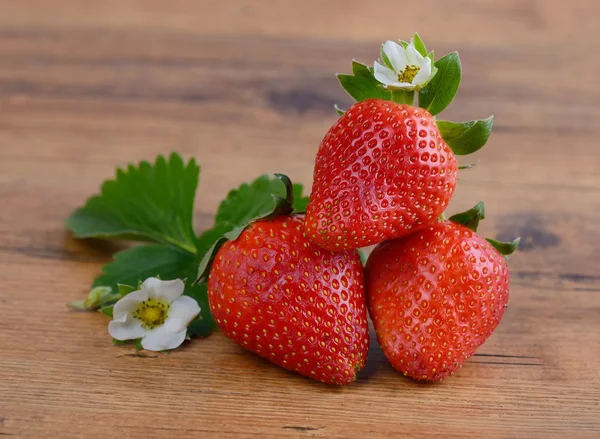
[437, 116, 494, 155]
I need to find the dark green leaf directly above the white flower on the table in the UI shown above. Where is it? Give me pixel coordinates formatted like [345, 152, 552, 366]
[93, 244, 214, 336]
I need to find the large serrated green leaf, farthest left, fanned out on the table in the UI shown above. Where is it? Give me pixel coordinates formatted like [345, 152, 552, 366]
[67, 153, 200, 253]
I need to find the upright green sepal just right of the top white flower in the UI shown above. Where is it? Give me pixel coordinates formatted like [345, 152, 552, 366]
[419, 52, 461, 116]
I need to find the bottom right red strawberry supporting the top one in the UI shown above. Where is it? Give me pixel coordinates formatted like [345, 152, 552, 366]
[365, 221, 509, 381]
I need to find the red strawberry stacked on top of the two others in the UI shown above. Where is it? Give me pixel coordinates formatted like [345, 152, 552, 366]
[305, 99, 458, 251]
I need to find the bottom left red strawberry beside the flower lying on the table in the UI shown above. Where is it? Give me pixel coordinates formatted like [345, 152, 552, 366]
[208, 215, 369, 384]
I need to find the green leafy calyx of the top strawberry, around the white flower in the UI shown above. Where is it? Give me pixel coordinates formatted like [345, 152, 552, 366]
[335, 33, 493, 155]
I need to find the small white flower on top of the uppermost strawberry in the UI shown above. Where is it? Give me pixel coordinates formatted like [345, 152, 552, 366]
[373, 41, 433, 90]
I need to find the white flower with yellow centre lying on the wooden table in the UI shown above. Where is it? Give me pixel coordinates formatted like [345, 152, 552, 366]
[108, 277, 200, 351]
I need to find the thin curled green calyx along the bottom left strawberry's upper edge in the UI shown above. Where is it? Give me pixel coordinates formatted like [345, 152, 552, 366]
[193, 174, 306, 285]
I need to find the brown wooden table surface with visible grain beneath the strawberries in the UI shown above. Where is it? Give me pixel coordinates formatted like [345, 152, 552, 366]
[0, 0, 600, 438]
